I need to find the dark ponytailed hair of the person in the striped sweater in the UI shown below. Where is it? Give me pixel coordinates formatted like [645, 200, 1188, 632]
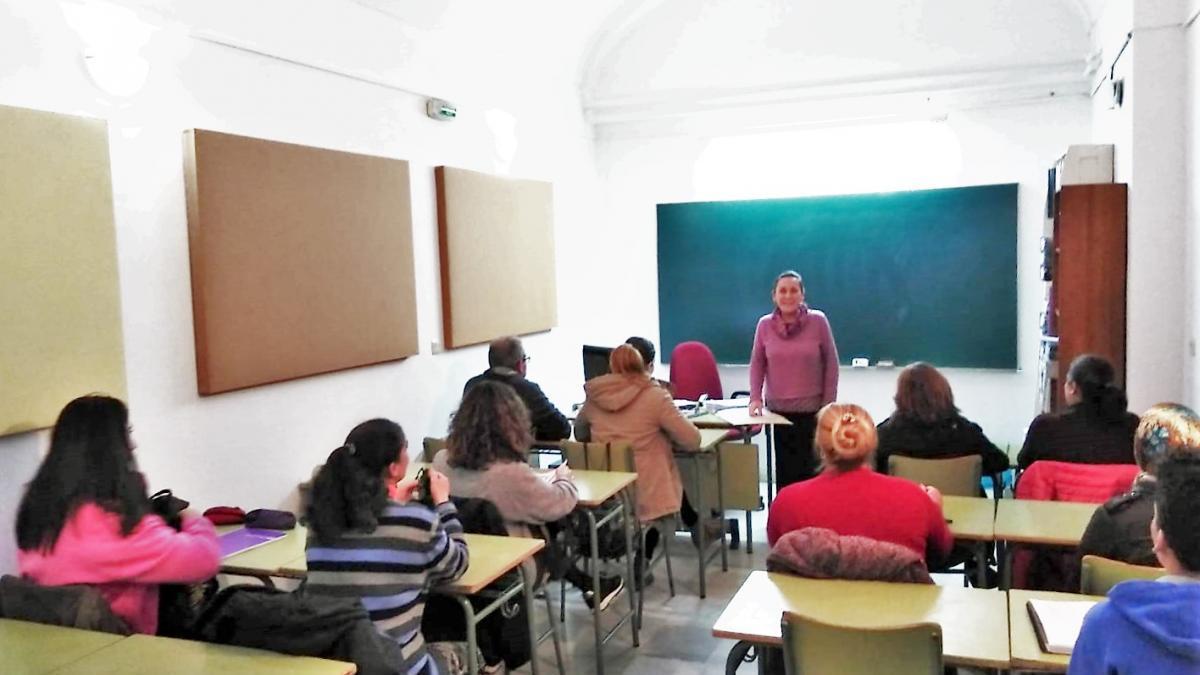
[307, 418, 407, 543]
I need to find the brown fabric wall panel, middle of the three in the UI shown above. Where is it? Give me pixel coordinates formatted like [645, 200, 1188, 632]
[184, 130, 418, 394]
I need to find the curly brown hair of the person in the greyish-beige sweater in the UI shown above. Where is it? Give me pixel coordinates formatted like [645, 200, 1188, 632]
[446, 381, 533, 471]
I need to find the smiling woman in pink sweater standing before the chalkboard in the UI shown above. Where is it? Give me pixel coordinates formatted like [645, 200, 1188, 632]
[750, 270, 838, 490]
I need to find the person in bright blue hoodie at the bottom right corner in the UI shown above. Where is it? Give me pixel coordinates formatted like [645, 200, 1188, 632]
[1068, 454, 1200, 675]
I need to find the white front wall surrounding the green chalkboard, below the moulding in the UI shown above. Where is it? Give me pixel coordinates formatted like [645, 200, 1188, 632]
[589, 97, 1090, 446]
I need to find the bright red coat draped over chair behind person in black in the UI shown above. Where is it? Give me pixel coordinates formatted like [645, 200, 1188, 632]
[1013, 460, 1139, 504]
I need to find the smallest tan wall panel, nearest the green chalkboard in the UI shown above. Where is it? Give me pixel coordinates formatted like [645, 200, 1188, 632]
[434, 167, 558, 348]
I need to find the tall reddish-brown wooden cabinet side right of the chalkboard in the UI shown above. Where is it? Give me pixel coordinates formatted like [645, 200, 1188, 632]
[1049, 183, 1128, 407]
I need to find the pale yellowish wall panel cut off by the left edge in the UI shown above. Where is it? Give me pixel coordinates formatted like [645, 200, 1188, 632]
[0, 106, 125, 436]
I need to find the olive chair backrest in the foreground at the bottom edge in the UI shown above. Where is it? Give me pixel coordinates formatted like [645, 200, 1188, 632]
[781, 611, 942, 675]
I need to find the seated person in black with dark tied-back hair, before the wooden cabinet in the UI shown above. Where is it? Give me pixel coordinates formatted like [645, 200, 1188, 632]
[1016, 354, 1138, 471]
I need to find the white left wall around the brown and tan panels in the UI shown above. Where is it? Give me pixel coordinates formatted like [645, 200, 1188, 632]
[0, 0, 609, 572]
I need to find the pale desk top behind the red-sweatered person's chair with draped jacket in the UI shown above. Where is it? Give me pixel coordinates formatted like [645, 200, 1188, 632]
[713, 571, 1009, 669]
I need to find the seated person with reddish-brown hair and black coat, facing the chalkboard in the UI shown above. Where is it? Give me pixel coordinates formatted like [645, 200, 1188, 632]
[875, 362, 1008, 476]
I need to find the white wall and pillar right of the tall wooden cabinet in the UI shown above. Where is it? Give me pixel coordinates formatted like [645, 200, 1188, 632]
[1093, 0, 1196, 411]
